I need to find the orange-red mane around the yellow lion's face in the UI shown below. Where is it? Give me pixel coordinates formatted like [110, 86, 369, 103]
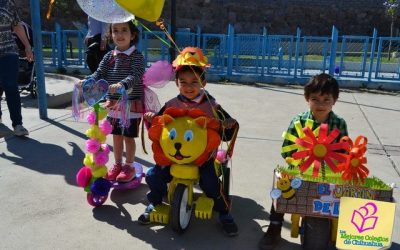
[149, 107, 221, 166]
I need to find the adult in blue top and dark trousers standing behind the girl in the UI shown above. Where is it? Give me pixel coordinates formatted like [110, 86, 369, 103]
[85, 16, 110, 73]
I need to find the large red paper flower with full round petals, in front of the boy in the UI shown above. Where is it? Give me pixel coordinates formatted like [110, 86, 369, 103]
[293, 123, 348, 177]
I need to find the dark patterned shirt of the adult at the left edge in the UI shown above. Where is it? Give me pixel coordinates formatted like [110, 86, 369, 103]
[0, 0, 20, 56]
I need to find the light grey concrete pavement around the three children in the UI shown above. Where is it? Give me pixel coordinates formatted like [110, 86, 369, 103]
[0, 76, 400, 250]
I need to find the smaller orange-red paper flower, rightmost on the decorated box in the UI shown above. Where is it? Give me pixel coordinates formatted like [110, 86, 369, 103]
[338, 135, 369, 183]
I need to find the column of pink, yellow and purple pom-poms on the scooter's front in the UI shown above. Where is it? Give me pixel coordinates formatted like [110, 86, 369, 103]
[76, 103, 112, 196]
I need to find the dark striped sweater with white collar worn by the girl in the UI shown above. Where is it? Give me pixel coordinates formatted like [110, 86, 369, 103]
[87, 47, 145, 100]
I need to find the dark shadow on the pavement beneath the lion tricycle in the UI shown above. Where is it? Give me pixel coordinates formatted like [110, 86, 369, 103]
[93, 194, 282, 249]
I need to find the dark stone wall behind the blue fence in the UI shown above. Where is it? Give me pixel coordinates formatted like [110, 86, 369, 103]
[16, 0, 400, 36]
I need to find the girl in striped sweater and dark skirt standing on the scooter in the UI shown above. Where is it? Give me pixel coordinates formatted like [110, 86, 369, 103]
[80, 21, 145, 182]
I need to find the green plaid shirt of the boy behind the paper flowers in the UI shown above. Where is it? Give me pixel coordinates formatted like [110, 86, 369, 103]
[282, 111, 348, 159]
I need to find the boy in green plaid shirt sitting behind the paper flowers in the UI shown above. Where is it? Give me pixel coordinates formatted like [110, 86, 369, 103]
[258, 73, 348, 250]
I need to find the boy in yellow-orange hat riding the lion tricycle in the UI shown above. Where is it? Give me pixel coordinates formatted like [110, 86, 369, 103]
[138, 48, 238, 236]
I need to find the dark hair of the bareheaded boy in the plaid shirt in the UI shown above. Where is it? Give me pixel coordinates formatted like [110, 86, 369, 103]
[304, 73, 339, 100]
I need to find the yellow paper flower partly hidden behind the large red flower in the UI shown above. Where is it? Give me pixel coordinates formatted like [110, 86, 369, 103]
[281, 119, 319, 167]
